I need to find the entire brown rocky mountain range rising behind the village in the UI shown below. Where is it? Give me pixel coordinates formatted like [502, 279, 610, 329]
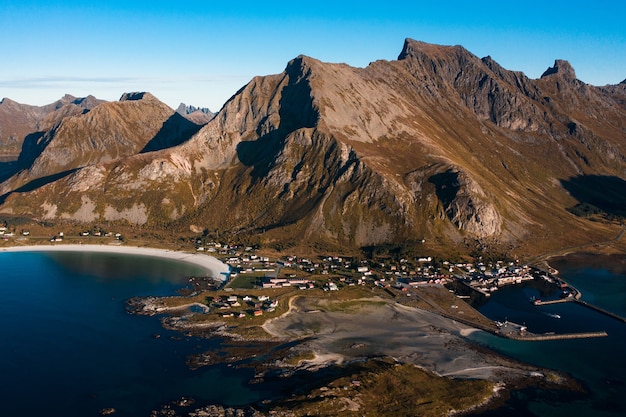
[0, 39, 626, 254]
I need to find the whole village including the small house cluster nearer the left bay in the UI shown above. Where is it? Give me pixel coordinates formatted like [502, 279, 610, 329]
[189, 241, 554, 319]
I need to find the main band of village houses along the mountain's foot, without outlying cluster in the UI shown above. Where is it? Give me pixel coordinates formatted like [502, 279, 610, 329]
[197, 237, 540, 296]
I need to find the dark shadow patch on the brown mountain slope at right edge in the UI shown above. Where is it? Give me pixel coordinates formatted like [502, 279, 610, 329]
[561, 175, 626, 218]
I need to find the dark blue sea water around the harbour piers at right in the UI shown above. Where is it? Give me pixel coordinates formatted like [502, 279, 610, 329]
[471, 254, 626, 417]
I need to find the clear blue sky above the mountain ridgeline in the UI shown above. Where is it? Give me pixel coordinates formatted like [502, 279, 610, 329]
[0, 0, 626, 111]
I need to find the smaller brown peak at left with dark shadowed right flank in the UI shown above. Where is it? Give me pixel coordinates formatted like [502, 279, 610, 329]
[0, 93, 200, 195]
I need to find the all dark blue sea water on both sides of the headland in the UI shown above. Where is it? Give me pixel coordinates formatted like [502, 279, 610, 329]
[0, 252, 626, 417]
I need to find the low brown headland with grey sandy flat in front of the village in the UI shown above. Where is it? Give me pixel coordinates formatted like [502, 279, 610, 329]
[135, 286, 582, 416]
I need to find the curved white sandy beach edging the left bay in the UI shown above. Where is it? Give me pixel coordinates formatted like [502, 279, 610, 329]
[0, 244, 230, 281]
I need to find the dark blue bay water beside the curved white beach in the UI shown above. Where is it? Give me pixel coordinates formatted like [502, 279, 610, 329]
[0, 252, 265, 417]
